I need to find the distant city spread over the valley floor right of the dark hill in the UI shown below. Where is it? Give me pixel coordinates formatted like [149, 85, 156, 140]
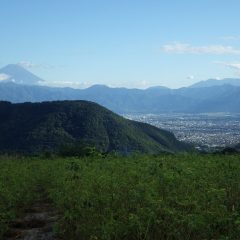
[124, 113, 240, 150]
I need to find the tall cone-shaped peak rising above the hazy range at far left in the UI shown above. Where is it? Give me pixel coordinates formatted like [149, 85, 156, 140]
[0, 64, 43, 85]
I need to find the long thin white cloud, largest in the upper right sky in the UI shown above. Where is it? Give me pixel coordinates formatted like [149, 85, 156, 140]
[163, 43, 240, 55]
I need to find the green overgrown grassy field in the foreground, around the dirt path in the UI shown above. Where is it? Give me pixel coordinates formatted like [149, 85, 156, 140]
[0, 154, 240, 240]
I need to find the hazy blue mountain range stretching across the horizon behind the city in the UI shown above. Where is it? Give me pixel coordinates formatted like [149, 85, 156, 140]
[0, 65, 240, 114]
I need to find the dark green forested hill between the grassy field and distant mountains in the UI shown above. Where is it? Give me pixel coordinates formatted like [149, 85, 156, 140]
[0, 101, 189, 153]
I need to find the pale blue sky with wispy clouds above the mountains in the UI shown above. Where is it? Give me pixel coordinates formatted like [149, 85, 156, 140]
[0, 0, 240, 88]
